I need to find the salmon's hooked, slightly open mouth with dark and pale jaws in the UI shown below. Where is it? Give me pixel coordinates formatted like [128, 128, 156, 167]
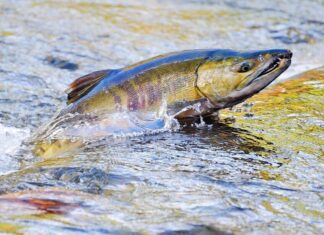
[221, 50, 292, 108]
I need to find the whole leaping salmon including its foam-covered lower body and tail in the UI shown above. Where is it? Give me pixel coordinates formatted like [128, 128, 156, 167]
[31, 49, 292, 156]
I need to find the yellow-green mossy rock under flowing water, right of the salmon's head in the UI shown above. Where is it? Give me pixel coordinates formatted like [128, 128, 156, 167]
[221, 67, 324, 157]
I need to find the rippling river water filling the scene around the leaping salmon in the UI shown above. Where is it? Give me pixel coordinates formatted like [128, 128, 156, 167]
[0, 0, 324, 234]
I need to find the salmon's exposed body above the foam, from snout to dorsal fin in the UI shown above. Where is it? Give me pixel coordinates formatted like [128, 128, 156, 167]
[61, 49, 291, 121]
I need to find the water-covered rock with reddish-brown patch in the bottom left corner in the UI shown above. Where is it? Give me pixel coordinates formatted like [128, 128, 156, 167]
[0, 189, 138, 234]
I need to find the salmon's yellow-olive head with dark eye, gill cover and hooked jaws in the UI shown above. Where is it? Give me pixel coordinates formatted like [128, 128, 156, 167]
[196, 49, 292, 109]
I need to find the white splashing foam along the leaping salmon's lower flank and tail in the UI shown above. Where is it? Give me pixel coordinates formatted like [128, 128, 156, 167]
[33, 109, 180, 140]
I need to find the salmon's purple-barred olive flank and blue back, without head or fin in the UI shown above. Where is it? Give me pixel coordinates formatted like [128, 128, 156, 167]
[67, 50, 221, 116]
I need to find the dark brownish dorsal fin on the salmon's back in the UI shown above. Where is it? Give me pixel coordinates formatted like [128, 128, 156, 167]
[65, 69, 118, 104]
